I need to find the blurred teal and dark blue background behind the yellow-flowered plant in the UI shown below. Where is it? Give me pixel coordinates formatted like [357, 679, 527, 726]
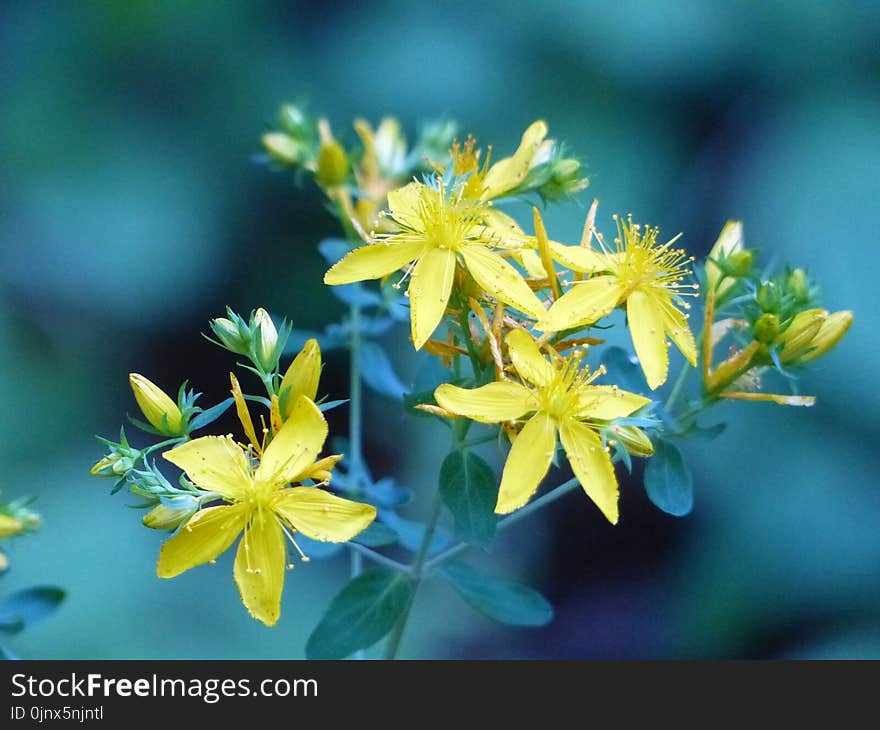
[0, 0, 880, 658]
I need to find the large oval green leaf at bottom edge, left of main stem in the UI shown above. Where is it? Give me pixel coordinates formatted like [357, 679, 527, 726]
[306, 568, 413, 659]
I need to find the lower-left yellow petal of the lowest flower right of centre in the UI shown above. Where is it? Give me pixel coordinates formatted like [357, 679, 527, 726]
[495, 413, 556, 515]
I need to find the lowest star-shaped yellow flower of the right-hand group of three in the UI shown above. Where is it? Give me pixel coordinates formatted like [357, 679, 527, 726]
[435, 330, 650, 524]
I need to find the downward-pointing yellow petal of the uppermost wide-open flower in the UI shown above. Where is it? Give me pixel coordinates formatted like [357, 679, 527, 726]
[409, 248, 455, 350]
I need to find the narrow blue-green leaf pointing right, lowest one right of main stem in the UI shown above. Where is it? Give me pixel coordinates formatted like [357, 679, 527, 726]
[440, 560, 553, 626]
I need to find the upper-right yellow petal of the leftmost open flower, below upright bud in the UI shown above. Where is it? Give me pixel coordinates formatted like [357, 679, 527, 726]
[254, 395, 327, 486]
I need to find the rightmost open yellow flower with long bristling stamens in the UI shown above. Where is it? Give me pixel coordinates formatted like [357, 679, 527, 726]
[538, 216, 697, 390]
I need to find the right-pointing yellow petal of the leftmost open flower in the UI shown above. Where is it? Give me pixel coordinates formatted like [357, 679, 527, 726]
[273, 487, 376, 542]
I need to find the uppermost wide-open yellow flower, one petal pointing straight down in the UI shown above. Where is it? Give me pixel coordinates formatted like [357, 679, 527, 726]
[324, 182, 545, 349]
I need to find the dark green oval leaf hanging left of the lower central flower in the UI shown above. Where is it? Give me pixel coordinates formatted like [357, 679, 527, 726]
[440, 451, 498, 548]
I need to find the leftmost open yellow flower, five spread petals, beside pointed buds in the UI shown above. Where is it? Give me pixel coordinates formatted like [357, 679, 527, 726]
[157, 396, 376, 626]
